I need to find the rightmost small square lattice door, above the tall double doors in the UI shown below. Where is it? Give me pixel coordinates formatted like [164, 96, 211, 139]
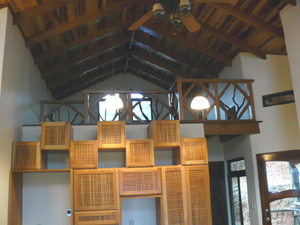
[180, 138, 208, 165]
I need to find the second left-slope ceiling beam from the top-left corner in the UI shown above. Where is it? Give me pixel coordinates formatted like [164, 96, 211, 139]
[25, 0, 138, 46]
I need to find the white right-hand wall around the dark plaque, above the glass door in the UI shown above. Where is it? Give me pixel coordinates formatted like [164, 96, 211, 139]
[221, 53, 300, 224]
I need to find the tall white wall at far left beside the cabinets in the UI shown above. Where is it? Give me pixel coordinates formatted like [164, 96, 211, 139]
[0, 8, 50, 224]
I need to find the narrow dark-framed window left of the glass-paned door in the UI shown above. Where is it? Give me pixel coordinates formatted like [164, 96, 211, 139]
[228, 158, 250, 225]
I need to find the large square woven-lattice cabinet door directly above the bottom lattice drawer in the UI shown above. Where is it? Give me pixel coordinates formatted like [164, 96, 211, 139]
[74, 169, 119, 211]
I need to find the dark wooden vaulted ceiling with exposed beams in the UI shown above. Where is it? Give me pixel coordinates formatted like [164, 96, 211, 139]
[0, 0, 296, 99]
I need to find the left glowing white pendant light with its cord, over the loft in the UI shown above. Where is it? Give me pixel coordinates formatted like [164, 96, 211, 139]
[104, 1, 124, 110]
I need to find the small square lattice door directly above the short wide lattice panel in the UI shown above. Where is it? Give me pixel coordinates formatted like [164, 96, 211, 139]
[126, 139, 154, 167]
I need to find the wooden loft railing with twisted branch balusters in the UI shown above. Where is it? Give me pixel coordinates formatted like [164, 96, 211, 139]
[41, 79, 256, 124]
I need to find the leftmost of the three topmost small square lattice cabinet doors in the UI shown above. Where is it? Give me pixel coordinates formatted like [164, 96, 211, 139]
[41, 122, 72, 150]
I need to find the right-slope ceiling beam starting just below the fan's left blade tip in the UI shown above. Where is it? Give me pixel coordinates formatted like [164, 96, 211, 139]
[144, 22, 232, 66]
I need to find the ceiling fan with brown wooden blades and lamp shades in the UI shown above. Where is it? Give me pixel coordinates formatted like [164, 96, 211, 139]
[128, 0, 238, 33]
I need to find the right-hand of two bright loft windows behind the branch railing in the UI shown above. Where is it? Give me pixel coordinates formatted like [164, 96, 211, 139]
[131, 93, 152, 122]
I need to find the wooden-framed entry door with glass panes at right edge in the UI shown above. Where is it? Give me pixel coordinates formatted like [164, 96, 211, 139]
[256, 150, 300, 225]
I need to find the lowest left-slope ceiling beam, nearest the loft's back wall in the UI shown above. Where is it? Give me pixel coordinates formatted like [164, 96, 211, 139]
[52, 63, 125, 99]
